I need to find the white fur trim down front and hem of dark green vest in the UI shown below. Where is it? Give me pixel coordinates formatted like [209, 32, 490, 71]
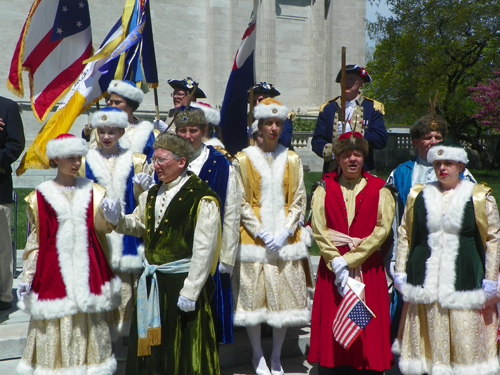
[402, 181, 486, 309]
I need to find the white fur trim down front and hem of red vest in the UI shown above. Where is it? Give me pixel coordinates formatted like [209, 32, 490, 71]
[20, 178, 121, 319]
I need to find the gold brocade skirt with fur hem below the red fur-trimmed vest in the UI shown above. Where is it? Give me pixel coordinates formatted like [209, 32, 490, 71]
[16, 313, 116, 374]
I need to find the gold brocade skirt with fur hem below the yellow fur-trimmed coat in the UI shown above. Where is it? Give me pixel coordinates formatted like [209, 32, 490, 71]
[231, 258, 314, 328]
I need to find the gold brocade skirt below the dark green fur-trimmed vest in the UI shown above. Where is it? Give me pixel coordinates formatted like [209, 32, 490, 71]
[398, 302, 500, 374]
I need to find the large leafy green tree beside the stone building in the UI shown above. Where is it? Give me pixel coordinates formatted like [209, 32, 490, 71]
[365, 0, 500, 166]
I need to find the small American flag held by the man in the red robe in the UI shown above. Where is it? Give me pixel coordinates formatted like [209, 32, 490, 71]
[333, 289, 372, 349]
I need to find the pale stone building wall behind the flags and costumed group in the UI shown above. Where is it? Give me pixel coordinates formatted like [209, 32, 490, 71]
[0, 0, 366, 186]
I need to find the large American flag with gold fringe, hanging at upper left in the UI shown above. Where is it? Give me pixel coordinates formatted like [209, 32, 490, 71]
[7, 0, 92, 122]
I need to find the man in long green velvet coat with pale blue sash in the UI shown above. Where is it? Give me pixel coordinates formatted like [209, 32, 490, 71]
[103, 134, 220, 375]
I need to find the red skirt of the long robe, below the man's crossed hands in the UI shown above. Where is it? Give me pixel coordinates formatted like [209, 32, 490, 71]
[308, 251, 394, 371]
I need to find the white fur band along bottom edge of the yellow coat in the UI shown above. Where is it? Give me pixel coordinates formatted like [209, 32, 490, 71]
[238, 241, 309, 264]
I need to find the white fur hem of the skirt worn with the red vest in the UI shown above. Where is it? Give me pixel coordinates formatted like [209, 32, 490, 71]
[16, 355, 117, 375]
